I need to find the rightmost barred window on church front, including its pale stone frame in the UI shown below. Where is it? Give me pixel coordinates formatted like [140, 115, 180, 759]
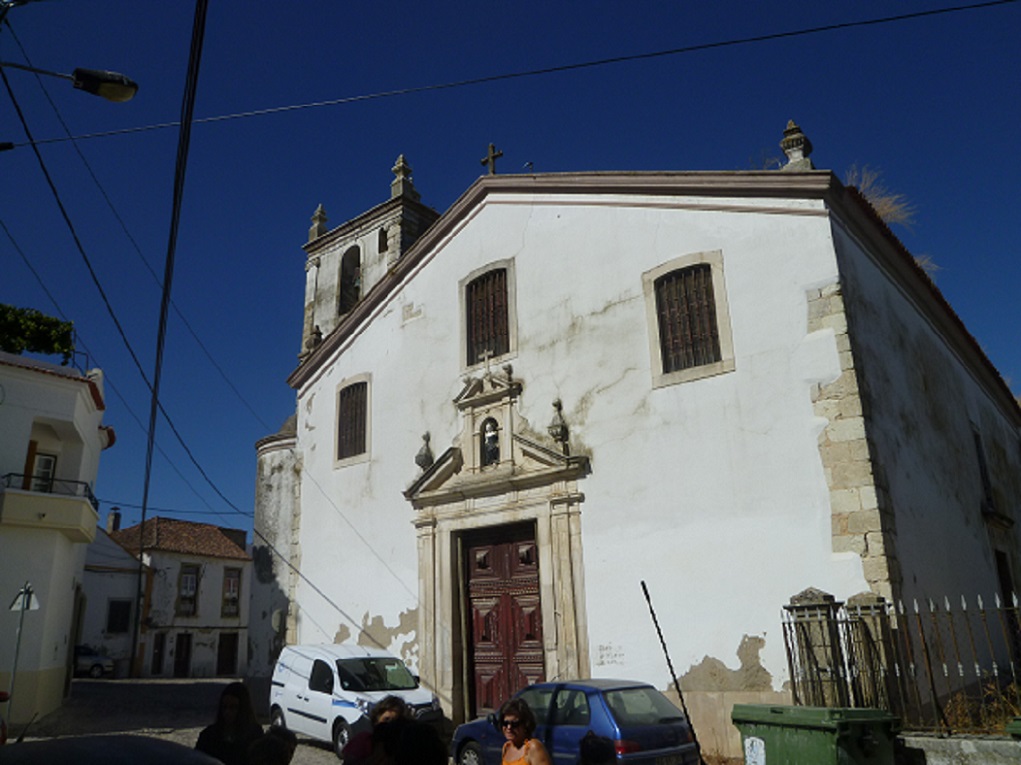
[642, 250, 734, 387]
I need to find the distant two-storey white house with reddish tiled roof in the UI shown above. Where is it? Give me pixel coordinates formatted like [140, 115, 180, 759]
[109, 517, 251, 677]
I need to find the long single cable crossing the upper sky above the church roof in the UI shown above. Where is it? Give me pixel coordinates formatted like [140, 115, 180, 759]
[3, 0, 1019, 148]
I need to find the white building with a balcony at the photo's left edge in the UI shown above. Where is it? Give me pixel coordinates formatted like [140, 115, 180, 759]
[0, 352, 114, 723]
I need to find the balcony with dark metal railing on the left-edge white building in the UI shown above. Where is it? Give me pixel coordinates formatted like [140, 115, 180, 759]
[0, 473, 99, 542]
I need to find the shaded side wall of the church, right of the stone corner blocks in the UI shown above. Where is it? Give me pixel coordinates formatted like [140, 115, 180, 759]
[834, 216, 1021, 602]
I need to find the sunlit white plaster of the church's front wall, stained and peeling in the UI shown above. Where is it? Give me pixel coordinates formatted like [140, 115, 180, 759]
[289, 187, 867, 692]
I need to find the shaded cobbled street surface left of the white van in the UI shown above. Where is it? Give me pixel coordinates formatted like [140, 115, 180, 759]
[8, 679, 340, 765]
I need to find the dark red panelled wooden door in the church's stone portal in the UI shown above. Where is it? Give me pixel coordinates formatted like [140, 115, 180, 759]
[464, 523, 545, 714]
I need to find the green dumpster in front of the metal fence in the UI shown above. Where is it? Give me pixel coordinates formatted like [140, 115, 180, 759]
[731, 704, 897, 765]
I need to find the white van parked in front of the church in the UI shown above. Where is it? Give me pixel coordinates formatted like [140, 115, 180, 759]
[270, 643, 443, 757]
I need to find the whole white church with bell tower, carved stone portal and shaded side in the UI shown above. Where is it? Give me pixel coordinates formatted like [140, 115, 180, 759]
[253, 124, 1021, 750]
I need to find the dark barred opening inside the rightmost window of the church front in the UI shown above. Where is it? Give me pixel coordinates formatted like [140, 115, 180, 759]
[655, 264, 721, 373]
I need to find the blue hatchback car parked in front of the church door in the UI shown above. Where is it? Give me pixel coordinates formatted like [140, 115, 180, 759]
[450, 680, 698, 765]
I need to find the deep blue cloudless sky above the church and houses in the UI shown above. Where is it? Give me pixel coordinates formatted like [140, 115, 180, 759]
[0, 0, 1021, 528]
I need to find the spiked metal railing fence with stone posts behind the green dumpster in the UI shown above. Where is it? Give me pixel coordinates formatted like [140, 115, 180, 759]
[782, 591, 1021, 733]
